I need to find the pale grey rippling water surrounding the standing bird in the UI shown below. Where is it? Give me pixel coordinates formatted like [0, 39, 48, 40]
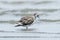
[0, 0, 60, 40]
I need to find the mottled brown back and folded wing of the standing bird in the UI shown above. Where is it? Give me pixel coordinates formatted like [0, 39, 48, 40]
[19, 16, 34, 25]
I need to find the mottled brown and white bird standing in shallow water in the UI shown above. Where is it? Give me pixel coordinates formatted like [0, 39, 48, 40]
[15, 13, 39, 30]
